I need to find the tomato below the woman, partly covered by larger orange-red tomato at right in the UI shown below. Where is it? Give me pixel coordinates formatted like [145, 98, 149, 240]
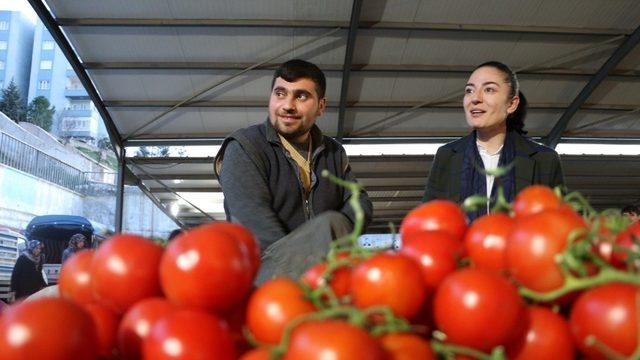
[464, 213, 515, 272]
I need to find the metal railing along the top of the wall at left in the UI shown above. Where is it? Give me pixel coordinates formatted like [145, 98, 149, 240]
[0, 133, 88, 192]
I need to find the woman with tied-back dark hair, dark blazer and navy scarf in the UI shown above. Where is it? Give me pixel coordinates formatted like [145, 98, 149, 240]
[423, 61, 564, 220]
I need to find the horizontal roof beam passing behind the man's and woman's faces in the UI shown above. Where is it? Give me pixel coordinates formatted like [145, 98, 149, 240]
[104, 99, 637, 111]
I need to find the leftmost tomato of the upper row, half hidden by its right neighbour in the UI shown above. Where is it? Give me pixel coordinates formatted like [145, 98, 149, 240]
[58, 250, 94, 304]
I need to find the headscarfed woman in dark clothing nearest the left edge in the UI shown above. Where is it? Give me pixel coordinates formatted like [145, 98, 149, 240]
[11, 240, 47, 300]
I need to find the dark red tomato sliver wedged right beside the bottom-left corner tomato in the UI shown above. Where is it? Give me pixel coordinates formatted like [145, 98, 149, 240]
[83, 304, 120, 359]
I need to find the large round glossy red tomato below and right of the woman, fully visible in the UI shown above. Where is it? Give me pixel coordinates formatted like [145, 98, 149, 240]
[433, 268, 525, 352]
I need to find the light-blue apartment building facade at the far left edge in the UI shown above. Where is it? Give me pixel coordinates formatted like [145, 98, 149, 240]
[0, 10, 34, 105]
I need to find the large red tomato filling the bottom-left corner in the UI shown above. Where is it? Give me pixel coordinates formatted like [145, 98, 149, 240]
[0, 298, 98, 360]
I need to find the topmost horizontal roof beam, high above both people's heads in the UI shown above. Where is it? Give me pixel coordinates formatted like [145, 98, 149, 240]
[57, 18, 629, 36]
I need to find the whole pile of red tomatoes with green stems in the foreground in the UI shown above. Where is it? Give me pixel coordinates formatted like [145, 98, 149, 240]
[0, 186, 640, 360]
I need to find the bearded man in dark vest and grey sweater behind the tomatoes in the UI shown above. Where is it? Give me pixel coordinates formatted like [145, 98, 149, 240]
[215, 60, 372, 284]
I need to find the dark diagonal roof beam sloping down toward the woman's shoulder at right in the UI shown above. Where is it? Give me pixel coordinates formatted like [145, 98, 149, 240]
[544, 26, 640, 148]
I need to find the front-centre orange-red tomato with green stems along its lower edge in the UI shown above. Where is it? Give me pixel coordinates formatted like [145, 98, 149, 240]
[351, 253, 427, 318]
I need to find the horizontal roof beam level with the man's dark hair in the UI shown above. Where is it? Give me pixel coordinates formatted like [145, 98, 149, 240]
[82, 61, 640, 77]
